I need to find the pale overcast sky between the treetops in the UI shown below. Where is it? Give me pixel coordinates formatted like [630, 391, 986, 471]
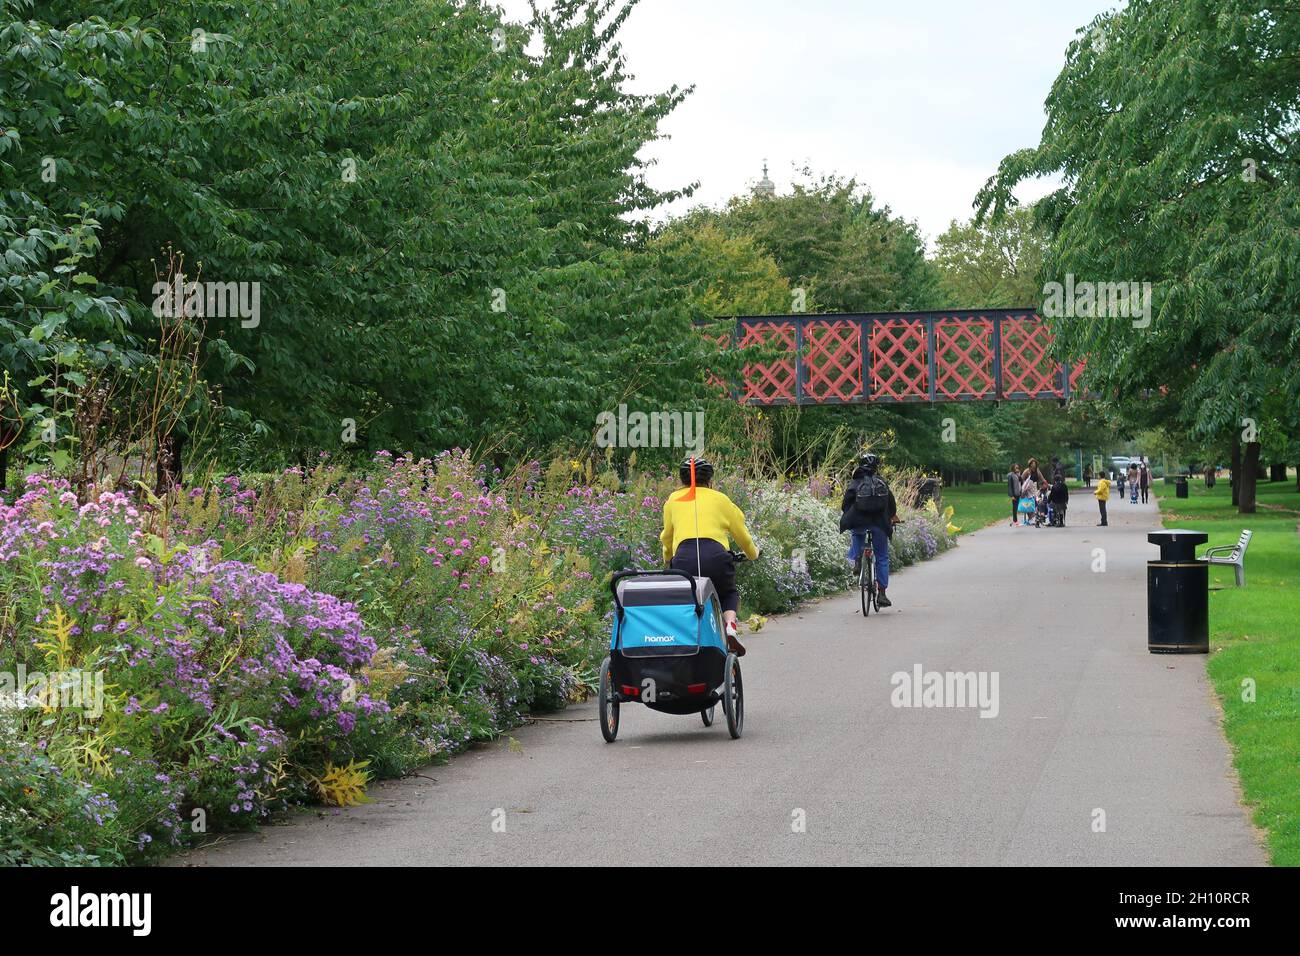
[501, 0, 1115, 247]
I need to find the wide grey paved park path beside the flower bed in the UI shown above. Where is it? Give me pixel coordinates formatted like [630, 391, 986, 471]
[176, 492, 1266, 866]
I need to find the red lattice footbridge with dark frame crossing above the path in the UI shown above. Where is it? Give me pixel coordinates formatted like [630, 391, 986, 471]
[706, 308, 1084, 405]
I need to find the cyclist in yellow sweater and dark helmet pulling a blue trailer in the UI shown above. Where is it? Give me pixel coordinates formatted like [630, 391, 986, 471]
[659, 458, 758, 657]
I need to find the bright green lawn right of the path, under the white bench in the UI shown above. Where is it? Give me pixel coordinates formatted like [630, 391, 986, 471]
[1154, 479, 1300, 866]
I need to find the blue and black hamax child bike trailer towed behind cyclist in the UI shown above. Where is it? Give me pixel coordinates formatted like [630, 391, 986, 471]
[599, 571, 745, 743]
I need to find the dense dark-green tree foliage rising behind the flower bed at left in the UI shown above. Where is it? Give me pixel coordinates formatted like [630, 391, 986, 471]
[0, 0, 701, 468]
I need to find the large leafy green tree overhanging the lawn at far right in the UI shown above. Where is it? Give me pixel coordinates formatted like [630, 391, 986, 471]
[978, 0, 1300, 511]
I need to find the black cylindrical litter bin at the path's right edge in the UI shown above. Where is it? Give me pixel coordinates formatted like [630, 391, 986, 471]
[1147, 528, 1210, 654]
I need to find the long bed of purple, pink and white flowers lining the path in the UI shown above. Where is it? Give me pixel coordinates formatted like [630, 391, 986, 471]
[0, 453, 952, 864]
